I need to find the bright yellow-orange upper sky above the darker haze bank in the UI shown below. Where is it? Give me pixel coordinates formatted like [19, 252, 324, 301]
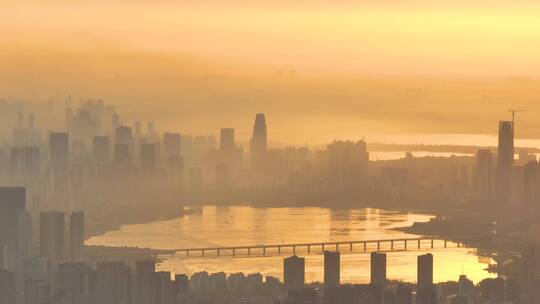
[0, 0, 540, 74]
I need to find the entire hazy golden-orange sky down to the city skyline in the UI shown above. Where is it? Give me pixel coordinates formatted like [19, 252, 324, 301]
[0, 0, 540, 142]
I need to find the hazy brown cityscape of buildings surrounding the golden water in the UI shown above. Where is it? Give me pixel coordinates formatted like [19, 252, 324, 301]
[0, 100, 540, 304]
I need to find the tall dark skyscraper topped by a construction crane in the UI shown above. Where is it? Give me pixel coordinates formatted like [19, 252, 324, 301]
[497, 121, 514, 205]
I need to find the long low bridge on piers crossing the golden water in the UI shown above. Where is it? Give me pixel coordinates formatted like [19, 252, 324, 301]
[174, 237, 462, 258]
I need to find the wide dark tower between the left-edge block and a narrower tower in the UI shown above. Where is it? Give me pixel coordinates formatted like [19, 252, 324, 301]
[39, 211, 64, 259]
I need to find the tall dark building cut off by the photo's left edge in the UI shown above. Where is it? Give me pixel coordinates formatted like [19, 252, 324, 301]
[0, 187, 26, 269]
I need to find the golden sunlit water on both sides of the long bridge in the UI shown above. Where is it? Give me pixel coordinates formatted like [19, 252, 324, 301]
[86, 206, 494, 283]
